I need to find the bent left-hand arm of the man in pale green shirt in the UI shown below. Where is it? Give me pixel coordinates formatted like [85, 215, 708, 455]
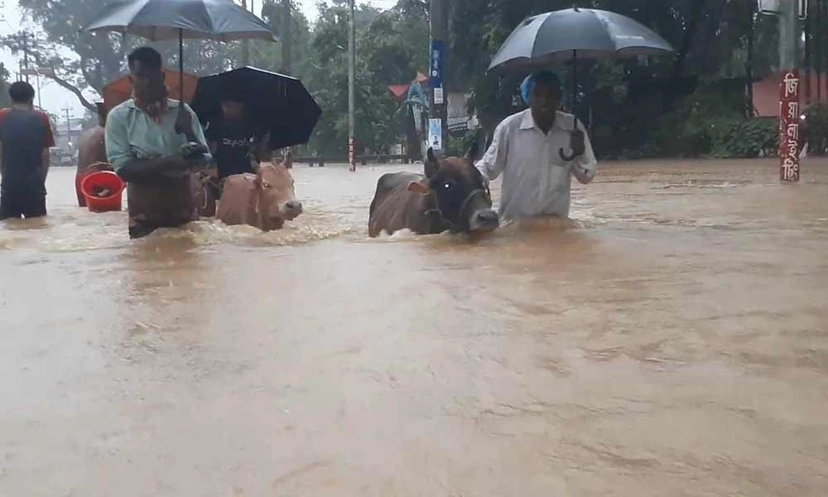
[104, 109, 188, 181]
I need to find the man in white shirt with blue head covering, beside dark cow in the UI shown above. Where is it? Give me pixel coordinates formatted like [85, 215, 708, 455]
[477, 71, 597, 220]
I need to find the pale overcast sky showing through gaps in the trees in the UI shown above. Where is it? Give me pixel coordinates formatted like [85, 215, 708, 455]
[0, 0, 397, 119]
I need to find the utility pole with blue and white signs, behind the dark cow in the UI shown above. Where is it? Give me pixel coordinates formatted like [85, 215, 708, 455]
[427, 0, 450, 152]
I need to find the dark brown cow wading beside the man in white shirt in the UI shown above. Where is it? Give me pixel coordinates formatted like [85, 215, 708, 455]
[368, 144, 499, 237]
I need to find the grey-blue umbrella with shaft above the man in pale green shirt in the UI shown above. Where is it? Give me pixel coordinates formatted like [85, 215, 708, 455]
[84, 0, 274, 101]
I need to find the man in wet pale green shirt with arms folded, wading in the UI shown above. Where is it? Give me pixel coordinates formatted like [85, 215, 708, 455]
[105, 47, 212, 238]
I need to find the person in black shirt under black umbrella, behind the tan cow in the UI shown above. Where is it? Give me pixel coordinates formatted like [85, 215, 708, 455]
[201, 83, 271, 216]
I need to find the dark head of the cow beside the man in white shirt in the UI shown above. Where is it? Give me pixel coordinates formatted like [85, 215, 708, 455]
[408, 148, 500, 232]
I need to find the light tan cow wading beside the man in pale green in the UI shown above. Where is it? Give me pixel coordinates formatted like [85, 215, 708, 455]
[216, 155, 302, 231]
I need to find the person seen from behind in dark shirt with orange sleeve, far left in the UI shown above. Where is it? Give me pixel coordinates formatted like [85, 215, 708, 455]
[0, 81, 55, 219]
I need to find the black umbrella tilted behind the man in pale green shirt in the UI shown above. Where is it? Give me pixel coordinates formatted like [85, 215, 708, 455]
[191, 67, 322, 149]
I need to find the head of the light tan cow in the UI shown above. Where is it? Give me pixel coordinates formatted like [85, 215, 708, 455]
[256, 153, 302, 229]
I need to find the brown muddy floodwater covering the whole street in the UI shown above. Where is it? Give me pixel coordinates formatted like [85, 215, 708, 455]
[0, 160, 828, 497]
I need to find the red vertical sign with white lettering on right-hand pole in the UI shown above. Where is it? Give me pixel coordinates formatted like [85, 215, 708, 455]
[779, 69, 801, 182]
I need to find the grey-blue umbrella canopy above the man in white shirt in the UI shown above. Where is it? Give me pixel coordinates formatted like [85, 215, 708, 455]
[489, 8, 674, 71]
